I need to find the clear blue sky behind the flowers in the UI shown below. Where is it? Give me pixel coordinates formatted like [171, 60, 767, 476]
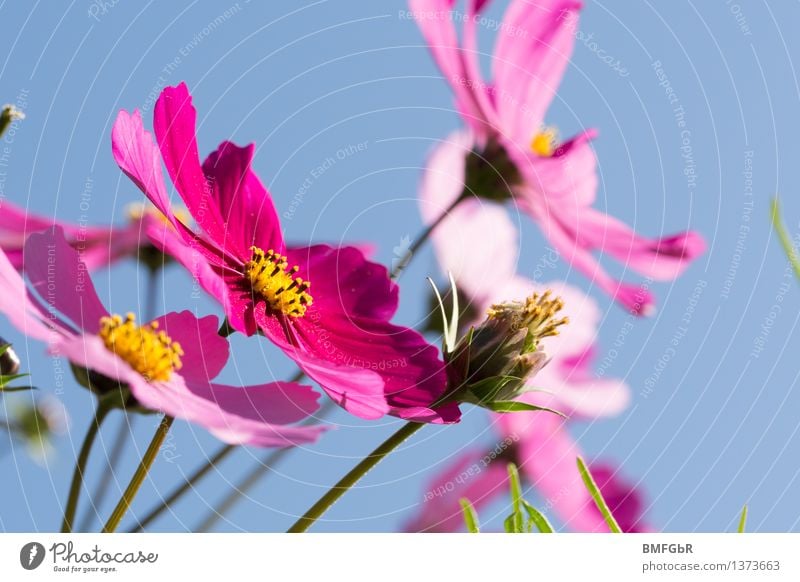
[0, 0, 800, 531]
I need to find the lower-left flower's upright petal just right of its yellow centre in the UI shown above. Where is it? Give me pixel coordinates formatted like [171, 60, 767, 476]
[155, 311, 230, 383]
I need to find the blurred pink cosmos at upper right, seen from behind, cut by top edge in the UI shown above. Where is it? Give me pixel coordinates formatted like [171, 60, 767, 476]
[410, 0, 705, 314]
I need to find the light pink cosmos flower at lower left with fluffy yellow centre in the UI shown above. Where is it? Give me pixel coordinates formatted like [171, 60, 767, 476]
[0, 227, 325, 447]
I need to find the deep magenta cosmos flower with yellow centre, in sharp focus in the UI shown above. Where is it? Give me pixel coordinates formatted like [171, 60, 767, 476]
[112, 84, 460, 423]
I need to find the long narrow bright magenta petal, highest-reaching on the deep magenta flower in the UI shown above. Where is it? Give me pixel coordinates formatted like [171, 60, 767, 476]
[153, 83, 225, 248]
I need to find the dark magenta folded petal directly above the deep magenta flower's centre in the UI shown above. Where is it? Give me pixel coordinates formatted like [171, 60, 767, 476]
[203, 141, 284, 261]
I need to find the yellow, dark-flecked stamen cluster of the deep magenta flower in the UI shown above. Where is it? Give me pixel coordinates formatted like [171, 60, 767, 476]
[244, 247, 313, 317]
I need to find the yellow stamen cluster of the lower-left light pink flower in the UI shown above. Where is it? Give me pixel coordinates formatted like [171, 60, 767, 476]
[100, 313, 183, 382]
